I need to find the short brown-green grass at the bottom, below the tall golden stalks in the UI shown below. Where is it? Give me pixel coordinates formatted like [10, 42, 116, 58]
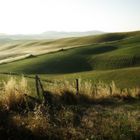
[1, 102, 140, 140]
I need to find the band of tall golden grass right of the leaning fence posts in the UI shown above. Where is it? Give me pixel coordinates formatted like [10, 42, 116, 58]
[45, 81, 140, 100]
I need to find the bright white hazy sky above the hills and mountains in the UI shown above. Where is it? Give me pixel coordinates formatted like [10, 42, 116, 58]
[0, 0, 140, 34]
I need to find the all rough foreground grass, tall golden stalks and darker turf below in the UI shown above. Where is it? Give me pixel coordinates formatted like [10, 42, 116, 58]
[0, 77, 140, 140]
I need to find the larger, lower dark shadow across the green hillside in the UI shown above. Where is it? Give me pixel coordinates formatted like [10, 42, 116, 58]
[24, 56, 92, 74]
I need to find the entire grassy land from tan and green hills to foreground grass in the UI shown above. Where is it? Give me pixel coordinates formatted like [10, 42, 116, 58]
[0, 32, 140, 140]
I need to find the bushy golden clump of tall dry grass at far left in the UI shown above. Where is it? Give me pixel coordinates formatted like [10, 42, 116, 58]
[0, 77, 29, 110]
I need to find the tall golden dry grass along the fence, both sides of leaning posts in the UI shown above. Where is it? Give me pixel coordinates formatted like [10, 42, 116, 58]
[0, 77, 140, 109]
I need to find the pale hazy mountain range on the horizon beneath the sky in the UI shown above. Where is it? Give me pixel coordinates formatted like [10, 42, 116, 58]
[0, 31, 104, 42]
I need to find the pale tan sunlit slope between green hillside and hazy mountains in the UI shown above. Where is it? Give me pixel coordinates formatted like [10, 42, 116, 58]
[0, 32, 138, 64]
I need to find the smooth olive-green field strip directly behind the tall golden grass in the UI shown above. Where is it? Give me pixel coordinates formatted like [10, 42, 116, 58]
[47, 67, 140, 88]
